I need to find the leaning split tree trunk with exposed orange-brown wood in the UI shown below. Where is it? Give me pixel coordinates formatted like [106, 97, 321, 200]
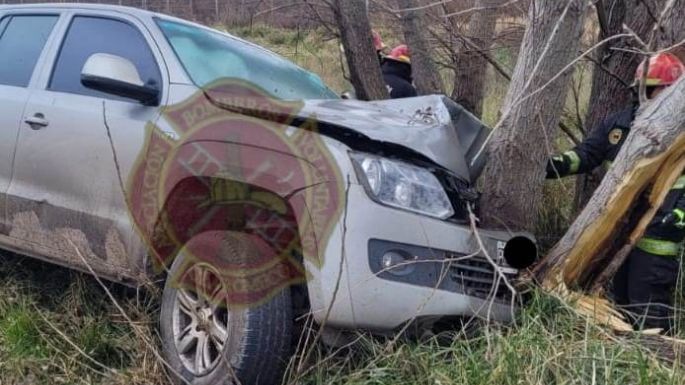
[536, 79, 685, 290]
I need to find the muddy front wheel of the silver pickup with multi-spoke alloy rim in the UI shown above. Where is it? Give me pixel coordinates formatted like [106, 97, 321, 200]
[160, 234, 293, 385]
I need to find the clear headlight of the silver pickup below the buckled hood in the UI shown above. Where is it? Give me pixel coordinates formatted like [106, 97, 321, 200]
[350, 153, 454, 219]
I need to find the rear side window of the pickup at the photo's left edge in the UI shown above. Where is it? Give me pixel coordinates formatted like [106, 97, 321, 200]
[0, 16, 58, 87]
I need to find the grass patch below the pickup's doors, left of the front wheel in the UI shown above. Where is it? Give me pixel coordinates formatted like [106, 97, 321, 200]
[0, 254, 164, 385]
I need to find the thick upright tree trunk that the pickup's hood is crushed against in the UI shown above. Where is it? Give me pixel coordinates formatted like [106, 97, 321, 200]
[481, 0, 588, 231]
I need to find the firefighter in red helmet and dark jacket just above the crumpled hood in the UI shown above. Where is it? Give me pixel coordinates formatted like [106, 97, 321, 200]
[381, 44, 417, 99]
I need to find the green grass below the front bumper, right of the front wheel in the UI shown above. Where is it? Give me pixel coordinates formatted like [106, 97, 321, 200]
[296, 295, 685, 385]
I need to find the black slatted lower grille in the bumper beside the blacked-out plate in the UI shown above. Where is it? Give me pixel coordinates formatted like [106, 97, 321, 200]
[450, 257, 514, 301]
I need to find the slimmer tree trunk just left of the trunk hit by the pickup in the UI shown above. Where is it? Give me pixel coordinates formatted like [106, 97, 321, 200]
[452, 0, 502, 117]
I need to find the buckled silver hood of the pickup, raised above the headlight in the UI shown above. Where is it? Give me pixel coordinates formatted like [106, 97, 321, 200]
[204, 84, 490, 183]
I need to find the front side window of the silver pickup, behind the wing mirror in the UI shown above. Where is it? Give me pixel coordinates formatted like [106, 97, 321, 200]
[48, 16, 162, 100]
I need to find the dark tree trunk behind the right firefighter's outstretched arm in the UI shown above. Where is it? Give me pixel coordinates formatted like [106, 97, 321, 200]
[574, 0, 665, 211]
